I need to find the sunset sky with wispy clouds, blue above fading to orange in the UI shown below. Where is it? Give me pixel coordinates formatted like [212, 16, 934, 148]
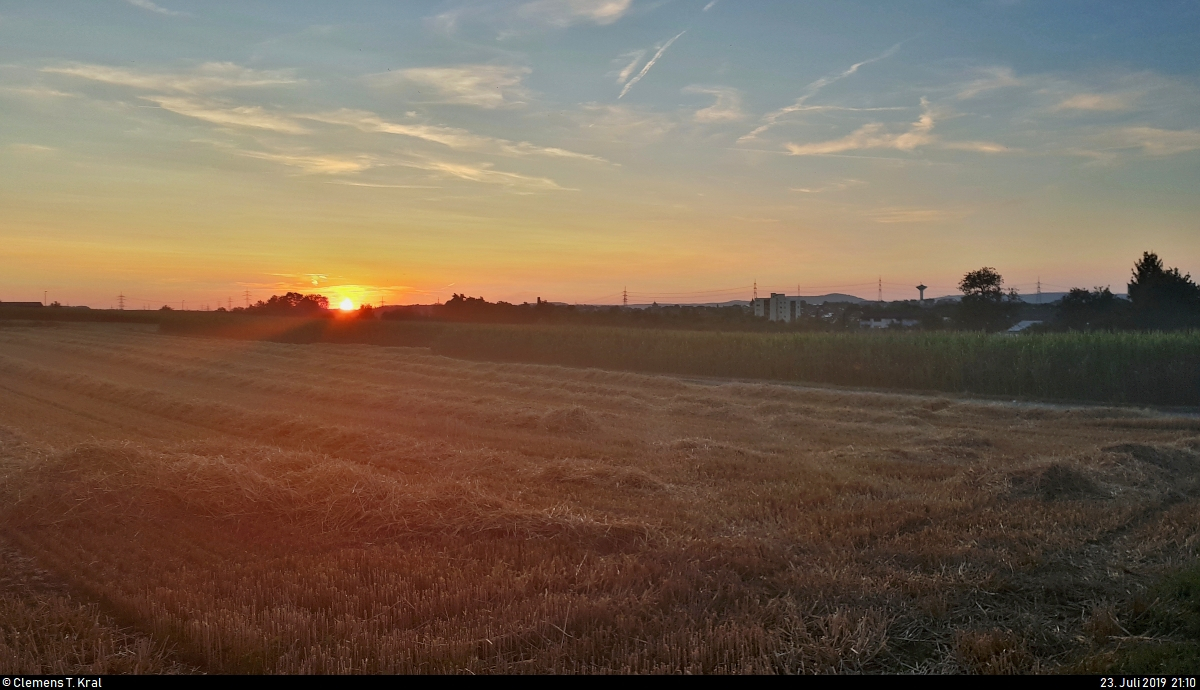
[0, 0, 1200, 308]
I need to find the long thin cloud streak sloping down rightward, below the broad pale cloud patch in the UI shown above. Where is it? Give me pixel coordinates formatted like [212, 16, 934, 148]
[298, 108, 607, 163]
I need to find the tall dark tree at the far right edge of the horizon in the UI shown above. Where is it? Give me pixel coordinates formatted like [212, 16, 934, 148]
[1129, 252, 1200, 329]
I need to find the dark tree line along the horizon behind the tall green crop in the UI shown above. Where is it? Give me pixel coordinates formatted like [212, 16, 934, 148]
[229, 252, 1200, 331]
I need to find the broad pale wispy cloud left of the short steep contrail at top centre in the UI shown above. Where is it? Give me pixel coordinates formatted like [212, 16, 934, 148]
[366, 65, 529, 108]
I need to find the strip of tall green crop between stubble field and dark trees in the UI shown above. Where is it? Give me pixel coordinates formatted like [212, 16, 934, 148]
[161, 318, 1200, 406]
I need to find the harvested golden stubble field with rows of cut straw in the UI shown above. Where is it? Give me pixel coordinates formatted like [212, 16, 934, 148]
[0, 324, 1200, 673]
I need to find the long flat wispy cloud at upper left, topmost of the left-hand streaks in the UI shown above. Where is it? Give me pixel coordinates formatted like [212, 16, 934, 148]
[42, 62, 301, 94]
